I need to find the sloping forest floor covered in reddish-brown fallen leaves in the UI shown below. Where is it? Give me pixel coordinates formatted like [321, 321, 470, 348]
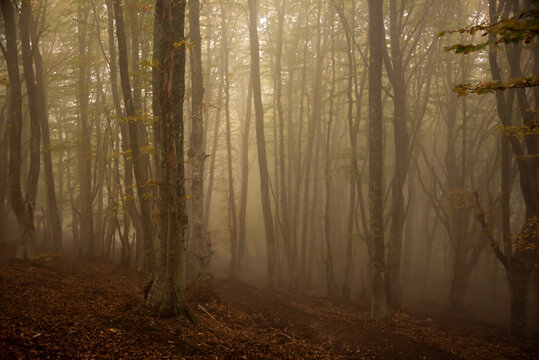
[0, 256, 539, 359]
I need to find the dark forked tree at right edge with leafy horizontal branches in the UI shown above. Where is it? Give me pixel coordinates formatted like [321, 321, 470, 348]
[448, 0, 539, 334]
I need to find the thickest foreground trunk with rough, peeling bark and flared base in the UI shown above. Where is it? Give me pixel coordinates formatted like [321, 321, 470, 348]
[146, 0, 189, 317]
